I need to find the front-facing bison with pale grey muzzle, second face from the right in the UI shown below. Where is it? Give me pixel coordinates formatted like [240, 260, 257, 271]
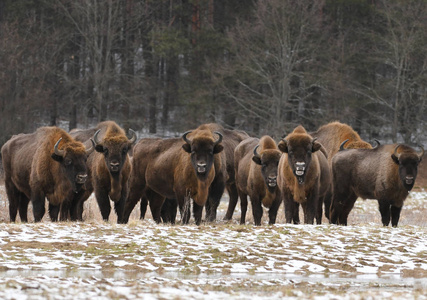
[278, 126, 331, 224]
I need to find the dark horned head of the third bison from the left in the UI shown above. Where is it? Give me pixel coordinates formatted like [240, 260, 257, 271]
[182, 131, 224, 180]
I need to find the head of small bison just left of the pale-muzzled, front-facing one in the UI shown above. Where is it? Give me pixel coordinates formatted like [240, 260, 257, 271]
[252, 145, 281, 193]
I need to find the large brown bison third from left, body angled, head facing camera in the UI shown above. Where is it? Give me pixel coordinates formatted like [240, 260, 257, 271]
[124, 129, 225, 224]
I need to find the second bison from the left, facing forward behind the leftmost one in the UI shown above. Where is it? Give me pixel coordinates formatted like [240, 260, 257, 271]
[70, 121, 136, 223]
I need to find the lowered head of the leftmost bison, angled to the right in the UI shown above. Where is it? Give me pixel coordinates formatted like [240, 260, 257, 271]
[52, 138, 94, 193]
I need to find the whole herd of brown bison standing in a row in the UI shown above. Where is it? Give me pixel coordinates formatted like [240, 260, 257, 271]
[1, 121, 424, 226]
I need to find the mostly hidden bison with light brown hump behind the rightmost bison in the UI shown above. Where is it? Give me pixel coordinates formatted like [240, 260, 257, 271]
[310, 122, 372, 219]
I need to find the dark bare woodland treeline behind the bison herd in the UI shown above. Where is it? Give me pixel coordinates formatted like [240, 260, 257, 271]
[0, 0, 427, 145]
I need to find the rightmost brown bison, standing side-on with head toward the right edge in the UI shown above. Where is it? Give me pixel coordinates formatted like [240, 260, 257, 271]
[331, 144, 424, 227]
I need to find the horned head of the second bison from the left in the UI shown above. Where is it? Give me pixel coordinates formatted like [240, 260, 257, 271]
[93, 129, 136, 175]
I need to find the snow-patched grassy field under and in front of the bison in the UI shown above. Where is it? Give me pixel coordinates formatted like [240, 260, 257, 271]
[0, 185, 427, 299]
